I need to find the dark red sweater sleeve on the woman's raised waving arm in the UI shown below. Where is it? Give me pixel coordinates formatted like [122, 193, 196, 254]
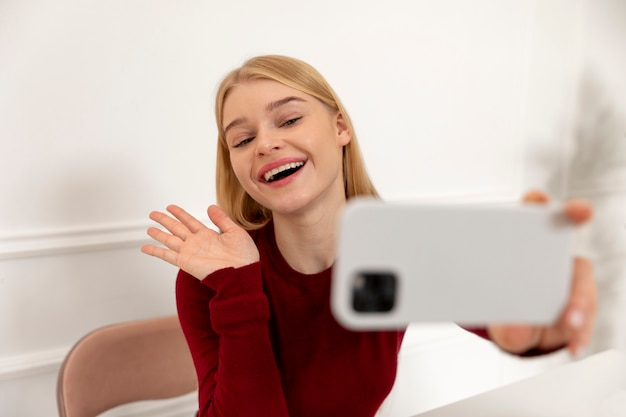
[176, 262, 288, 417]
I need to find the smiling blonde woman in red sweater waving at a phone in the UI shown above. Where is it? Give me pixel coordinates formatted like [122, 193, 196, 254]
[142, 56, 595, 417]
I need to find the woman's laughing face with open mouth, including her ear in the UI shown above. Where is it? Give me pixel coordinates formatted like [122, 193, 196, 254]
[222, 80, 351, 216]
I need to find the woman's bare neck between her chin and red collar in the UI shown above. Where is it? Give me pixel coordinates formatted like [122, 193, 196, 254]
[274, 200, 345, 274]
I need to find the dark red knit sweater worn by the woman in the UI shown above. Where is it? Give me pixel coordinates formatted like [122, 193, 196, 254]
[176, 223, 404, 417]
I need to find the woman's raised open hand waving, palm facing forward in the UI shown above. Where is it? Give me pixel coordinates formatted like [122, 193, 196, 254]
[141, 205, 259, 279]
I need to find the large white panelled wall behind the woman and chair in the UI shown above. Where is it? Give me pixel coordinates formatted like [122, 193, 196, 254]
[0, 0, 626, 416]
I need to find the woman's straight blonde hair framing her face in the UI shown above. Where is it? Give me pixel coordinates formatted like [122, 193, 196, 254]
[215, 55, 378, 230]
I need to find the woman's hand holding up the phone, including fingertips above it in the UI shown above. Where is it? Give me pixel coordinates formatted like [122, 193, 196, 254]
[487, 191, 597, 354]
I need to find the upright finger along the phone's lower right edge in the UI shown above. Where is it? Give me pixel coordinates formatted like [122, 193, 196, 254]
[565, 258, 597, 354]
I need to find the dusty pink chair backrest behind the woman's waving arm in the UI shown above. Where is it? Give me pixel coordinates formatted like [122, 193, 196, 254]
[57, 316, 197, 417]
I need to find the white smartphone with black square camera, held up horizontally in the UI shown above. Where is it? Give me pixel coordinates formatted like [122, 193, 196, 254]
[331, 199, 573, 330]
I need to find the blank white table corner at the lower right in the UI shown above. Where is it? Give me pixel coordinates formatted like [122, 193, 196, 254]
[416, 350, 626, 417]
